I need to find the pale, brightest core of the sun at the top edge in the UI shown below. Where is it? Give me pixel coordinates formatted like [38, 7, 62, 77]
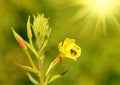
[86, 0, 115, 14]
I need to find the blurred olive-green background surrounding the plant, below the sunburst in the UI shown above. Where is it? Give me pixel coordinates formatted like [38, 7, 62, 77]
[0, 0, 120, 85]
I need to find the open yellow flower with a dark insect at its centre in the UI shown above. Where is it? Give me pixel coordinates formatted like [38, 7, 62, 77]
[58, 38, 81, 60]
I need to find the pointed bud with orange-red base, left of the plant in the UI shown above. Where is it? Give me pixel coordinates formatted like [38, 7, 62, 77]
[11, 28, 27, 50]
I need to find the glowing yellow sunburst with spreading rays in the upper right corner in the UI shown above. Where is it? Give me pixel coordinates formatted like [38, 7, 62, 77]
[71, 0, 120, 39]
